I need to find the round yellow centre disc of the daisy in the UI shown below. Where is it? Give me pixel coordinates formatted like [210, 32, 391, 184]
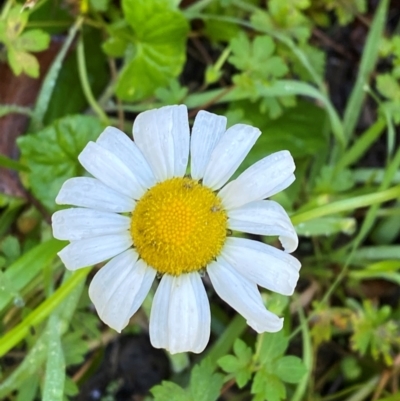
[131, 178, 227, 276]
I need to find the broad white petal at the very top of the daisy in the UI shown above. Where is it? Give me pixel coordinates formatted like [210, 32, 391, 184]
[133, 105, 189, 181]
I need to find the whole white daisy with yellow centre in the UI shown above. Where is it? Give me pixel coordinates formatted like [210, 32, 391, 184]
[53, 106, 300, 353]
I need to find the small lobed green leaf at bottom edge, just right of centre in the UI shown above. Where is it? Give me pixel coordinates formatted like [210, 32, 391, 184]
[190, 359, 223, 401]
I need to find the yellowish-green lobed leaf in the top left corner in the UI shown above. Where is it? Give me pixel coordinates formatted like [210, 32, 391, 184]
[0, 6, 50, 78]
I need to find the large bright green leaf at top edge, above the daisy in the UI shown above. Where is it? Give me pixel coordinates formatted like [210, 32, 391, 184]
[116, 0, 188, 101]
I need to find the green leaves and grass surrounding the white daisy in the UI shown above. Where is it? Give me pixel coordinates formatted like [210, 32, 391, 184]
[0, 0, 400, 401]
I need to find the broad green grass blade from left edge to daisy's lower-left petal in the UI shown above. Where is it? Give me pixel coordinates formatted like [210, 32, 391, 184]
[0, 239, 65, 311]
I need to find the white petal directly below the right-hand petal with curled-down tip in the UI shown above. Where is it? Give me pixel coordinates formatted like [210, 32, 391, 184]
[221, 238, 301, 295]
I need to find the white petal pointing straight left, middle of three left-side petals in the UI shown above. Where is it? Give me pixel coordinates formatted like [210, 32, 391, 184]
[52, 208, 131, 241]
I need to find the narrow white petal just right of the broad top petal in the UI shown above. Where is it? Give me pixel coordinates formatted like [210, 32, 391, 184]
[190, 110, 227, 180]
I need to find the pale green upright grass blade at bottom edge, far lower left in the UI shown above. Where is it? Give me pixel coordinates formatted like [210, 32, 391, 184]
[42, 315, 65, 401]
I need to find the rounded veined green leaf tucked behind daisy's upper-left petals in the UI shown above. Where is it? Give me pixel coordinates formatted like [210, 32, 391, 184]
[18, 115, 103, 211]
